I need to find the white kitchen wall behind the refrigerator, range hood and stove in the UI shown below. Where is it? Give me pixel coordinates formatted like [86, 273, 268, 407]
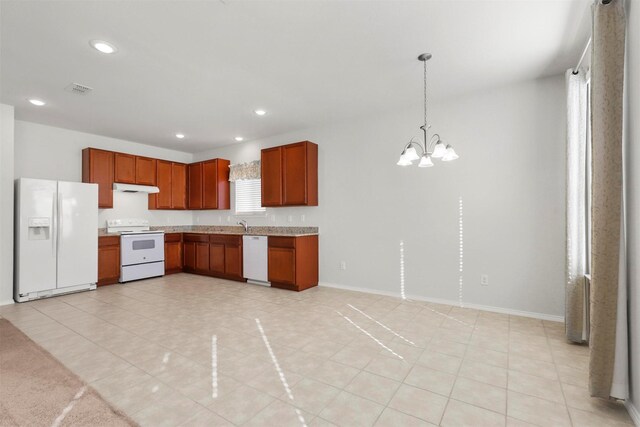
[15, 120, 193, 227]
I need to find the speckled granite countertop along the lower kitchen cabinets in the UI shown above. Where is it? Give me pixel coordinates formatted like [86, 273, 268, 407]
[98, 225, 318, 237]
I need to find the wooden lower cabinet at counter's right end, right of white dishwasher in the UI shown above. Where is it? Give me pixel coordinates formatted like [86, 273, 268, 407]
[268, 236, 318, 291]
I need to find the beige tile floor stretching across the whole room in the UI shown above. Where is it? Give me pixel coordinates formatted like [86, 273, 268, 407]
[0, 274, 632, 426]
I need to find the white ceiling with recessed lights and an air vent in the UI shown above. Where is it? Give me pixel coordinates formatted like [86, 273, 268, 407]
[0, 0, 591, 152]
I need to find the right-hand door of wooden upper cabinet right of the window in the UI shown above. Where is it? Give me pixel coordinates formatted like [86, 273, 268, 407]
[282, 143, 307, 205]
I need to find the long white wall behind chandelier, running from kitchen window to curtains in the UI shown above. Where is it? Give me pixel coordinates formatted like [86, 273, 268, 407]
[194, 76, 565, 316]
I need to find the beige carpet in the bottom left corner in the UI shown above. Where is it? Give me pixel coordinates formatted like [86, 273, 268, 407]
[0, 319, 136, 427]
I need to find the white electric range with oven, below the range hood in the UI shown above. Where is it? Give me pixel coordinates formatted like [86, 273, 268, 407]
[107, 218, 164, 283]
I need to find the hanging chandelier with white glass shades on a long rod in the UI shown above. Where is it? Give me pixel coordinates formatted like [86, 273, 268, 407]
[396, 53, 458, 168]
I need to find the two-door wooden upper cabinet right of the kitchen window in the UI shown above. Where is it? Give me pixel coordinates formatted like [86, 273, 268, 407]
[260, 141, 318, 207]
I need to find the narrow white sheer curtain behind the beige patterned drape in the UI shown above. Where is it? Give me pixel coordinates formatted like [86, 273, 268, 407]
[565, 69, 588, 343]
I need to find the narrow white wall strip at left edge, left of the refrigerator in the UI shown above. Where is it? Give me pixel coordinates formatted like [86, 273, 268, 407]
[0, 104, 14, 305]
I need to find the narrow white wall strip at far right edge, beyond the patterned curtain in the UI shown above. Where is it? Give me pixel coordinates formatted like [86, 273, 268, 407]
[626, 0, 640, 424]
